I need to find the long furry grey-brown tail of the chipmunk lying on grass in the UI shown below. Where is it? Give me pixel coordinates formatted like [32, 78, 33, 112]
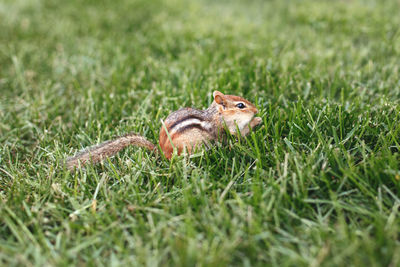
[66, 133, 156, 170]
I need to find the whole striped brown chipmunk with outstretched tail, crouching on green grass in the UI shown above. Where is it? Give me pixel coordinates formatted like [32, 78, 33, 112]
[66, 91, 261, 170]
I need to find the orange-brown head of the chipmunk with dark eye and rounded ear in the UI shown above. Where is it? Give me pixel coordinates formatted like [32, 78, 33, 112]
[213, 91, 258, 134]
